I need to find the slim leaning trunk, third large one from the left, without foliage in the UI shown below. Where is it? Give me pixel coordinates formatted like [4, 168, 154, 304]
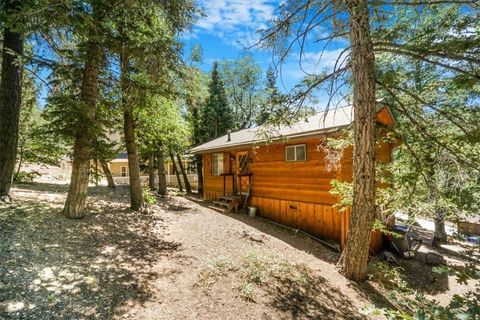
[120, 39, 144, 211]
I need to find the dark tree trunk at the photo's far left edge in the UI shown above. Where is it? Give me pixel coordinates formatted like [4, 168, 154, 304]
[0, 0, 24, 201]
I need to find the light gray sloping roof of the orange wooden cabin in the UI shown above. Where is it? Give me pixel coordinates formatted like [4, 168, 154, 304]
[190, 106, 353, 153]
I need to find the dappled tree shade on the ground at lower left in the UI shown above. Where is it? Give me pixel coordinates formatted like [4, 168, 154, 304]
[0, 183, 180, 319]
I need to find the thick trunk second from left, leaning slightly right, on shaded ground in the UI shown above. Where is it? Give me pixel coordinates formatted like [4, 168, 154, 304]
[63, 18, 102, 219]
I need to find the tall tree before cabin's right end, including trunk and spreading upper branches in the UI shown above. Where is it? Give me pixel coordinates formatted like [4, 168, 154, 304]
[260, 0, 480, 280]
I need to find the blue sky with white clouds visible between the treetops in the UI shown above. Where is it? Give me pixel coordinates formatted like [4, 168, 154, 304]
[183, 0, 345, 104]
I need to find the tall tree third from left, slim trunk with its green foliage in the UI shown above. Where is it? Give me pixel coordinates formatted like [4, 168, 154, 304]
[112, 0, 196, 210]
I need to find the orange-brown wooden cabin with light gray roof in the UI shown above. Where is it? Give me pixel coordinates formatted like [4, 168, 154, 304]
[191, 104, 394, 251]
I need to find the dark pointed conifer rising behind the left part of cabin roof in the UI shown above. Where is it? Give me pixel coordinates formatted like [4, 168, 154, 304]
[200, 62, 233, 140]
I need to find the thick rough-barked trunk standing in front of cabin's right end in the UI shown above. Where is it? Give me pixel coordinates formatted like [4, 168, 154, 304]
[339, 0, 376, 281]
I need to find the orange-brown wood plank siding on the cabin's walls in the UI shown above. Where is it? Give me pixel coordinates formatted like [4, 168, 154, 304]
[204, 133, 391, 250]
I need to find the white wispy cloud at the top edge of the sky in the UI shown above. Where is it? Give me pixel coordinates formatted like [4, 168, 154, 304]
[195, 0, 276, 46]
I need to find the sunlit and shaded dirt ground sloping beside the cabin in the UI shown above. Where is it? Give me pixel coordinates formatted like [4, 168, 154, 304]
[0, 183, 478, 319]
